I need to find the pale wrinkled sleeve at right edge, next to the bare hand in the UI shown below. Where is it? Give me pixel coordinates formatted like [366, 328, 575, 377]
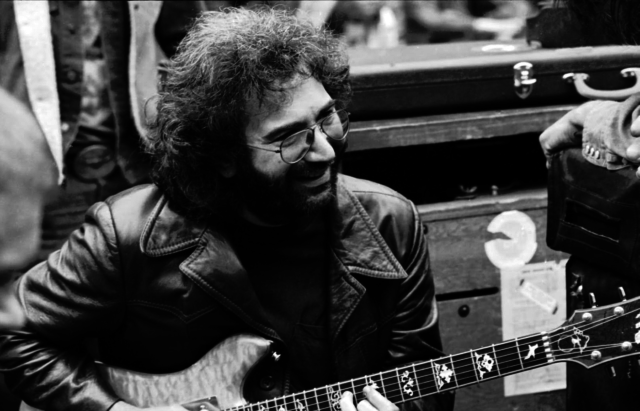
[582, 94, 640, 170]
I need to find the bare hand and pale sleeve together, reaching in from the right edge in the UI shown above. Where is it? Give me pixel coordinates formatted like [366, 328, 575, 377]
[540, 94, 640, 175]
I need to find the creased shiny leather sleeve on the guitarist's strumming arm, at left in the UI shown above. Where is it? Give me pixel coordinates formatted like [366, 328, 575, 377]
[0, 203, 124, 411]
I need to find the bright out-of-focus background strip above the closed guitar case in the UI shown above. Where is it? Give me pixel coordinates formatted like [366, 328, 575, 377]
[206, 0, 545, 48]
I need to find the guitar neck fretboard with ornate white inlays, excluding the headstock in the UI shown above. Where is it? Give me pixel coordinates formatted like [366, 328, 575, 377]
[229, 333, 557, 411]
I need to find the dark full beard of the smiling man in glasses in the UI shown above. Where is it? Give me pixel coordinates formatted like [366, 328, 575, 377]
[232, 158, 339, 223]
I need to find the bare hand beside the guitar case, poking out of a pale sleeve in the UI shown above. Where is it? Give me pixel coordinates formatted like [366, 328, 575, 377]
[540, 101, 604, 168]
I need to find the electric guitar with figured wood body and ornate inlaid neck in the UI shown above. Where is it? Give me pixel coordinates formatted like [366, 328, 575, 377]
[21, 297, 640, 411]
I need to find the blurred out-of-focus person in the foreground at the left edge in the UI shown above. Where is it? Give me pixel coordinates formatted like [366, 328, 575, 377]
[0, 89, 55, 329]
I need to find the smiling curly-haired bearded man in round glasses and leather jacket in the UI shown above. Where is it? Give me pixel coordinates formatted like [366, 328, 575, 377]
[0, 10, 452, 411]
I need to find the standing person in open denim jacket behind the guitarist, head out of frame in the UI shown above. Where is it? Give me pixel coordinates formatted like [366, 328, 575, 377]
[0, 1, 204, 261]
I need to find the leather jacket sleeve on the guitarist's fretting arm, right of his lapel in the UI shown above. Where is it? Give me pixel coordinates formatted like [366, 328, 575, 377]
[386, 204, 454, 411]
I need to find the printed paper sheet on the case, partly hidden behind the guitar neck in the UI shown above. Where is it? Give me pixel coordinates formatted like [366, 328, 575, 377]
[500, 260, 567, 396]
